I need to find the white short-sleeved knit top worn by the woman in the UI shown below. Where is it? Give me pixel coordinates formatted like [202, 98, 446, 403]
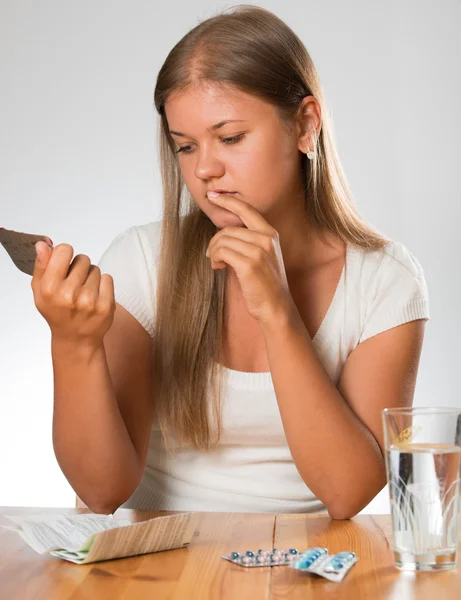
[99, 221, 429, 513]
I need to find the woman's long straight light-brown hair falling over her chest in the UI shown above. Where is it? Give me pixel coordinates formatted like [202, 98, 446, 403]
[153, 5, 387, 450]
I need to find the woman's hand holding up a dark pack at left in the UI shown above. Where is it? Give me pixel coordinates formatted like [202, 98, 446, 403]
[31, 242, 115, 345]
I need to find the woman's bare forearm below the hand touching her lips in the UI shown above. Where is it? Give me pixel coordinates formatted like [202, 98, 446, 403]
[262, 309, 386, 519]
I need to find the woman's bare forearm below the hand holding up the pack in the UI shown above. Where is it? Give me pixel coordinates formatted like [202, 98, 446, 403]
[52, 339, 142, 513]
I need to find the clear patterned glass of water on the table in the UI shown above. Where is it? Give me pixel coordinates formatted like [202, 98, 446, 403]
[382, 407, 461, 571]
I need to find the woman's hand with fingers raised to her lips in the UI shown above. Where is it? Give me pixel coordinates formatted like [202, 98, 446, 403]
[206, 194, 293, 324]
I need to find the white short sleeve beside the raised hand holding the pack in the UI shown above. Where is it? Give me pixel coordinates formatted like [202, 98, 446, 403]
[98, 221, 161, 336]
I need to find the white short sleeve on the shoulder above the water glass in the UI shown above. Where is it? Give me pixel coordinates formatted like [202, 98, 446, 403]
[359, 242, 430, 342]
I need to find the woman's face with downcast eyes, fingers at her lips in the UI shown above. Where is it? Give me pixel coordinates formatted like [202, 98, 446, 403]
[165, 84, 303, 229]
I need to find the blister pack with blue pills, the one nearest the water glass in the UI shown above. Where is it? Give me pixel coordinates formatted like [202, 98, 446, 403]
[290, 548, 358, 582]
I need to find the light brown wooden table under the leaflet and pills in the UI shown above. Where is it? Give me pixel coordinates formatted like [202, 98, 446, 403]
[0, 508, 461, 600]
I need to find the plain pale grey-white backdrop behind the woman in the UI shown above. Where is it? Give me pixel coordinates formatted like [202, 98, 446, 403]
[0, 0, 461, 512]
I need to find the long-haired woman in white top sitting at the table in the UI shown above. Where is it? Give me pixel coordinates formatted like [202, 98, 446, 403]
[32, 6, 429, 519]
